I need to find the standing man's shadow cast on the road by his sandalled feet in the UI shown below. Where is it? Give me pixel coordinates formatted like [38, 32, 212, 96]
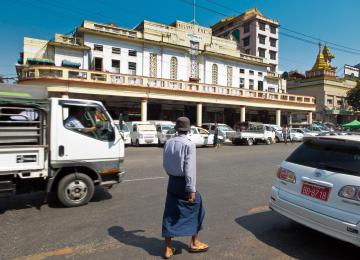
[108, 226, 188, 257]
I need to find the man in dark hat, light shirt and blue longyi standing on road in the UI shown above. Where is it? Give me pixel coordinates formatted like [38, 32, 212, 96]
[162, 117, 209, 259]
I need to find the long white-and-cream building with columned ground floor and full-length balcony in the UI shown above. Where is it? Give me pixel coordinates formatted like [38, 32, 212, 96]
[17, 15, 315, 125]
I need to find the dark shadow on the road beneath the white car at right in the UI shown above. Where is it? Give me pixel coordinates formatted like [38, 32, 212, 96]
[235, 211, 360, 259]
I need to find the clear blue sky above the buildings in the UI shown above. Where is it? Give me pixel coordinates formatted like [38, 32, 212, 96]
[0, 0, 360, 76]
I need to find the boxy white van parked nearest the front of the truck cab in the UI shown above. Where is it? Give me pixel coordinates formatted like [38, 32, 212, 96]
[127, 121, 158, 146]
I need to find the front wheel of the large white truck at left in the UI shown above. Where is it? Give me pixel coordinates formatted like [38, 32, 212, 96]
[57, 173, 95, 207]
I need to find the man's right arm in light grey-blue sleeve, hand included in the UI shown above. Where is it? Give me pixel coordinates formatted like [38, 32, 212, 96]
[184, 144, 196, 202]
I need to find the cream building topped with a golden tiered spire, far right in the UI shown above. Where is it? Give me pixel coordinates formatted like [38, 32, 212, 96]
[288, 44, 360, 124]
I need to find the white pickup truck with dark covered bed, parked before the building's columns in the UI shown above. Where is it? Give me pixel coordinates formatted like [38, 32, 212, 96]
[232, 123, 275, 146]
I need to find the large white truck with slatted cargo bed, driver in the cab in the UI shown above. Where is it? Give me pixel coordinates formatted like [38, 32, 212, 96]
[0, 84, 125, 207]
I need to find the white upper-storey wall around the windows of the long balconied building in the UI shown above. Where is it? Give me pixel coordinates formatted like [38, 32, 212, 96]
[50, 34, 278, 91]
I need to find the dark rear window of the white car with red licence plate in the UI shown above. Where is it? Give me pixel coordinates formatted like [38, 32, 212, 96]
[286, 140, 360, 176]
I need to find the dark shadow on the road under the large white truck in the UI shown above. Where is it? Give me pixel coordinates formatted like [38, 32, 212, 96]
[0, 187, 112, 214]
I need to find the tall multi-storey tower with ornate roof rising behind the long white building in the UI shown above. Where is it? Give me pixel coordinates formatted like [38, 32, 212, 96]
[211, 8, 279, 71]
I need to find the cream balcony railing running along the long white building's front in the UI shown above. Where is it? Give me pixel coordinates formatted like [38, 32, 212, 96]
[21, 66, 315, 105]
